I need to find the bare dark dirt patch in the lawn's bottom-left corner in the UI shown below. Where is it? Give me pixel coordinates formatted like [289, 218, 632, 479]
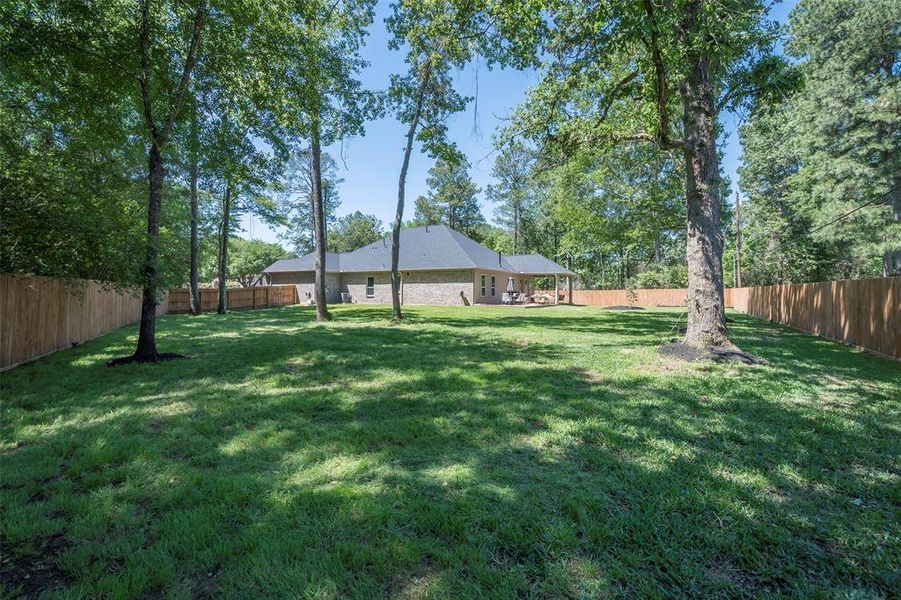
[0, 533, 73, 598]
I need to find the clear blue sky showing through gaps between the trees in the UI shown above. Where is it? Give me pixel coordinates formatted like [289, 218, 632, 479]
[241, 0, 796, 242]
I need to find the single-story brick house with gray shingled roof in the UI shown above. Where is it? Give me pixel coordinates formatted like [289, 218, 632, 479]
[264, 225, 575, 305]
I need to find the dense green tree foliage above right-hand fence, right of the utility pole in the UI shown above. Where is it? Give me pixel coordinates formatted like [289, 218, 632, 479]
[741, 1, 901, 284]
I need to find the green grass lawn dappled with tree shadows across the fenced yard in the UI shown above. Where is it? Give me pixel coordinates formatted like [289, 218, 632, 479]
[0, 306, 901, 598]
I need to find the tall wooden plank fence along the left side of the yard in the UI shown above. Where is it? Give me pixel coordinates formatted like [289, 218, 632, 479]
[0, 274, 166, 369]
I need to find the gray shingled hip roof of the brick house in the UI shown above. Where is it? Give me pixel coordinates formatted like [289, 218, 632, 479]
[264, 225, 574, 275]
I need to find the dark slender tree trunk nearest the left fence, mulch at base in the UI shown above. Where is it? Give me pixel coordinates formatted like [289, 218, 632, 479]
[134, 140, 165, 359]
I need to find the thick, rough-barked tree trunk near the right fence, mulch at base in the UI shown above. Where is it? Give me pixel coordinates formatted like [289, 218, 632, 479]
[680, 58, 734, 348]
